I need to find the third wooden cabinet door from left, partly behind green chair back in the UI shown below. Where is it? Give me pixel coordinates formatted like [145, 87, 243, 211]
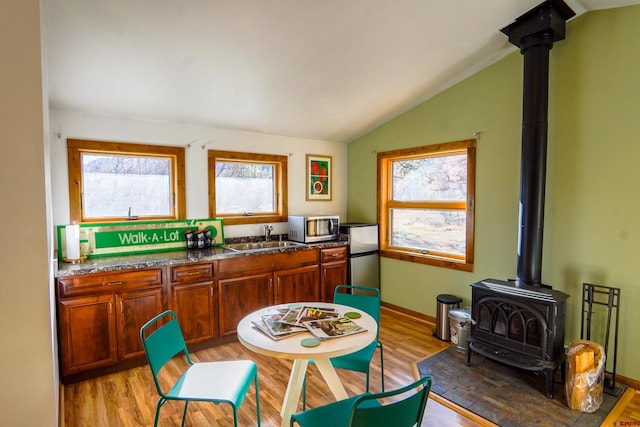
[170, 282, 218, 344]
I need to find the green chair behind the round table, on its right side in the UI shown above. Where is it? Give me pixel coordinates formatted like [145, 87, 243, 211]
[302, 285, 384, 409]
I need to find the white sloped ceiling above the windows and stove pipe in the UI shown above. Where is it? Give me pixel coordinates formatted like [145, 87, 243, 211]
[41, 0, 640, 141]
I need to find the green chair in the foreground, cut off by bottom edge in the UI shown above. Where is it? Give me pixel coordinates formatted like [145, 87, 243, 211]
[290, 377, 431, 427]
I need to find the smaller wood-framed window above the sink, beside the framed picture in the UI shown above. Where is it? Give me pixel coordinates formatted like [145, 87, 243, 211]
[209, 150, 288, 224]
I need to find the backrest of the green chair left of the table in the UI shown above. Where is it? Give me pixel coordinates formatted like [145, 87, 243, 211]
[140, 310, 193, 395]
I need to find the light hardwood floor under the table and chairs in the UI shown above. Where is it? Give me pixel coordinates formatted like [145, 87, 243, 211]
[61, 308, 640, 427]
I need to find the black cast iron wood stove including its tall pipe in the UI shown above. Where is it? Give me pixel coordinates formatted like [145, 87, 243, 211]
[467, 0, 575, 398]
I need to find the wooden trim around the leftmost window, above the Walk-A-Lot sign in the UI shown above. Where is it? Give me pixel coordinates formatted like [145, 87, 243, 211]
[67, 139, 186, 223]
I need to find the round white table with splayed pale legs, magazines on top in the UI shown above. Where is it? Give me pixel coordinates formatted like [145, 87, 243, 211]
[238, 302, 378, 427]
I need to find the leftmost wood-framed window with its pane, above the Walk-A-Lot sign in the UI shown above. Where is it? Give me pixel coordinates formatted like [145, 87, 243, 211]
[67, 139, 186, 222]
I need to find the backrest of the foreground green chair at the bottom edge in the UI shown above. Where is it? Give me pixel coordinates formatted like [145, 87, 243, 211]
[349, 377, 431, 427]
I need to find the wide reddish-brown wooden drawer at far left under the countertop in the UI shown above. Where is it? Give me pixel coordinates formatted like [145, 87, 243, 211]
[58, 269, 162, 298]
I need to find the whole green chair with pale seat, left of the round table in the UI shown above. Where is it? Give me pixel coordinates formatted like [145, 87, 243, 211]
[140, 310, 260, 427]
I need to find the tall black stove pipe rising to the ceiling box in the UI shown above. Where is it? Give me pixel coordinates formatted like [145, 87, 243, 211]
[500, 0, 575, 286]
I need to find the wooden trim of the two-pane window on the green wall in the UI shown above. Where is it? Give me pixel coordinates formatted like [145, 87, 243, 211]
[377, 139, 476, 271]
